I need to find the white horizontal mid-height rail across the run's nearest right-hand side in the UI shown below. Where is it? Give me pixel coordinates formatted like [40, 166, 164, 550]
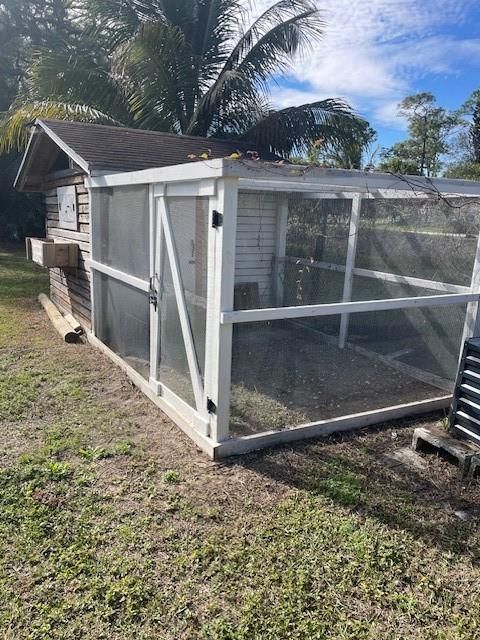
[221, 293, 480, 324]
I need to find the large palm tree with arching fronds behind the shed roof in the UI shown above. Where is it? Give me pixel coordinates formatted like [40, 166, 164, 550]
[0, 0, 364, 157]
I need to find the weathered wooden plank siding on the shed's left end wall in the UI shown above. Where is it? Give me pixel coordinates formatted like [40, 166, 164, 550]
[45, 173, 91, 330]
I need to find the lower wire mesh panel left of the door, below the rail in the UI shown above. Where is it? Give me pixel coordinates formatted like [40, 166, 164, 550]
[93, 272, 150, 379]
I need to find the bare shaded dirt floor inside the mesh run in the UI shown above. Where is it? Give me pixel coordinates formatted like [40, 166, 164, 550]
[231, 325, 445, 435]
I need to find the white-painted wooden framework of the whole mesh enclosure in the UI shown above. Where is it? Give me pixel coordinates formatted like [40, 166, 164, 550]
[87, 160, 480, 458]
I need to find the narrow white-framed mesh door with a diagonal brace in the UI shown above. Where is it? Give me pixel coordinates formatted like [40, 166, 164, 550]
[152, 196, 208, 436]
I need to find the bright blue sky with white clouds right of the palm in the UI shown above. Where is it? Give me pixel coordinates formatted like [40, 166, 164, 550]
[254, 0, 480, 151]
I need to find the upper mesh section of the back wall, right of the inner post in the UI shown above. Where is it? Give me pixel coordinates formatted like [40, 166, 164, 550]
[355, 197, 479, 286]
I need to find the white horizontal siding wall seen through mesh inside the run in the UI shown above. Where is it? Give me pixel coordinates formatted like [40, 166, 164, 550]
[235, 191, 278, 305]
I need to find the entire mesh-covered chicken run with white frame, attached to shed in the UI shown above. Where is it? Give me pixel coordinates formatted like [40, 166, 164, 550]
[87, 159, 480, 458]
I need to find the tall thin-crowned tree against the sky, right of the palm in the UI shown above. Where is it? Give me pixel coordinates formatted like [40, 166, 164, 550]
[379, 93, 460, 177]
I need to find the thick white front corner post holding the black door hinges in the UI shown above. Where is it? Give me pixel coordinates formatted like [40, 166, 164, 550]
[204, 178, 238, 442]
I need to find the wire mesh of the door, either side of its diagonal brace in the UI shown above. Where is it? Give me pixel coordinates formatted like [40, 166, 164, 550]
[159, 197, 208, 406]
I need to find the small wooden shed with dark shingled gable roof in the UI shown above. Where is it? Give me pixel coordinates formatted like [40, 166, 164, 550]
[15, 120, 275, 330]
